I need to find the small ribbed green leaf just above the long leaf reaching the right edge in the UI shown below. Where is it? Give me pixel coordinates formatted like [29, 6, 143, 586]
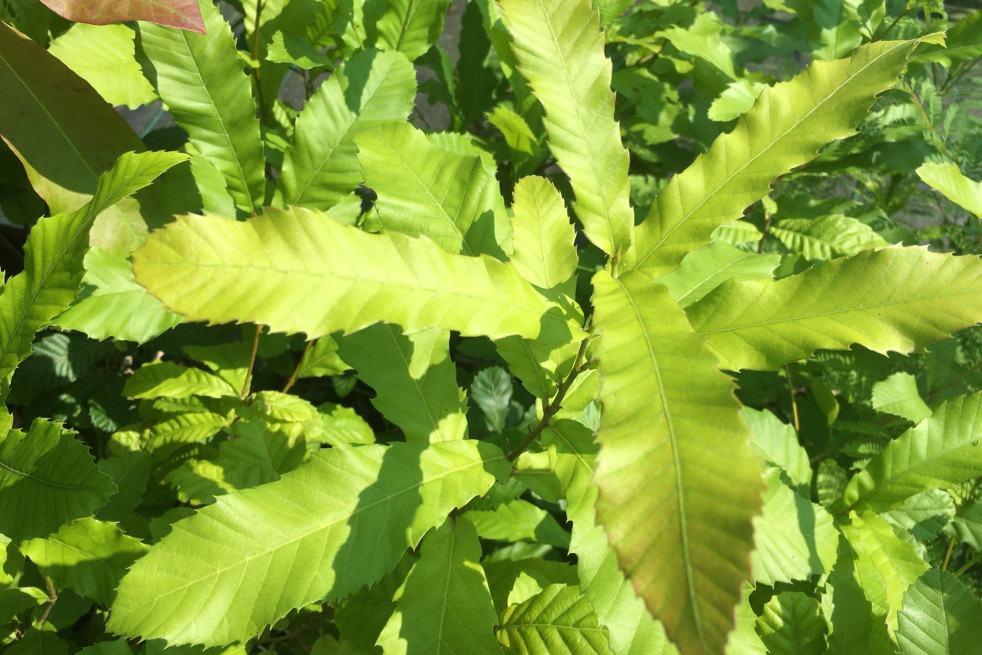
[770, 214, 890, 260]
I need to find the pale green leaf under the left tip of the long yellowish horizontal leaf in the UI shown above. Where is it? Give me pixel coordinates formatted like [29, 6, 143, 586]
[54, 248, 183, 343]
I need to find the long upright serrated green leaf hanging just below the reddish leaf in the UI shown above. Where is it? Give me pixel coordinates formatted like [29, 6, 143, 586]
[139, 0, 266, 214]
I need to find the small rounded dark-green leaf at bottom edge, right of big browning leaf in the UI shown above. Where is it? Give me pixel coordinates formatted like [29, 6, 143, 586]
[757, 591, 828, 655]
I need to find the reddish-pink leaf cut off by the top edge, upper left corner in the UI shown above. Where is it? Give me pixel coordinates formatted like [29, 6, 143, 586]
[41, 0, 205, 34]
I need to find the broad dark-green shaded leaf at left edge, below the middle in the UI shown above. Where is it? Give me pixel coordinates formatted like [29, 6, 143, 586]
[0, 414, 116, 542]
